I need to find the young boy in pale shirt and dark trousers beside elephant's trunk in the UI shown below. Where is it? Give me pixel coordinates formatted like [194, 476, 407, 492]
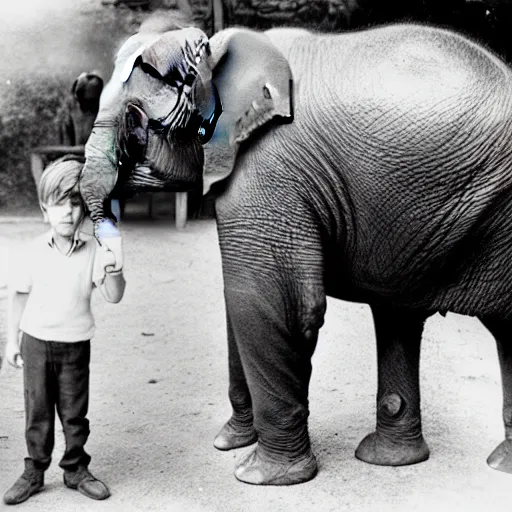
[4, 157, 125, 505]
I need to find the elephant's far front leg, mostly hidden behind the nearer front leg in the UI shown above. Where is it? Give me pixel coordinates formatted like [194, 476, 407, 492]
[213, 313, 258, 450]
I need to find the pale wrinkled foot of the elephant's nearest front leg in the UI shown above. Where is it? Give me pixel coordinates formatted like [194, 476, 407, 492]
[235, 447, 318, 485]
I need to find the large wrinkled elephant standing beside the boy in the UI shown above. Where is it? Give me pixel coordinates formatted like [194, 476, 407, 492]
[80, 24, 512, 485]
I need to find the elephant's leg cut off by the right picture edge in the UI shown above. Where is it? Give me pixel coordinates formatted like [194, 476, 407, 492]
[482, 319, 512, 473]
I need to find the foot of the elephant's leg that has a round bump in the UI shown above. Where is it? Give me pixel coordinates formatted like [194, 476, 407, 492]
[356, 432, 430, 466]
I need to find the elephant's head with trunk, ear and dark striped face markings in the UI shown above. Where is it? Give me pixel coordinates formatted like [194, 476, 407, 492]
[81, 28, 292, 230]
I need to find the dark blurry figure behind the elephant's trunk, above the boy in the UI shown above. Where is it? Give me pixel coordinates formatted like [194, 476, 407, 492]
[58, 72, 103, 146]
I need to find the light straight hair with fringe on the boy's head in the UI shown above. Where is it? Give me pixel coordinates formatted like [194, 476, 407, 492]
[39, 156, 84, 208]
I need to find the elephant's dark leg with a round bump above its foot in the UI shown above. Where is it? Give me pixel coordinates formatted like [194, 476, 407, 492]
[356, 306, 429, 466]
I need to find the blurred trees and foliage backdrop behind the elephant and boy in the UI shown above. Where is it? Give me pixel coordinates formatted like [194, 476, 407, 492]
[0, 0, 512, 214]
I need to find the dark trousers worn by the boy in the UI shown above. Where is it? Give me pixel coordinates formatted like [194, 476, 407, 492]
[20, 333, 91, 471]
